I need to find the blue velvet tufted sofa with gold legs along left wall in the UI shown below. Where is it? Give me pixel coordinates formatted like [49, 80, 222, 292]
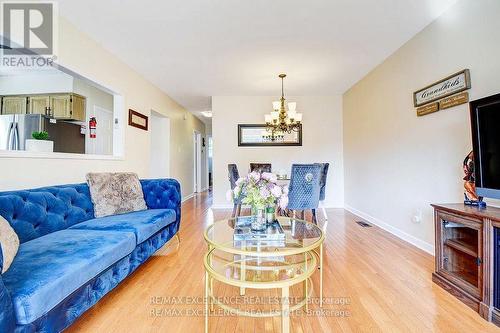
[0, 179, 181, 333]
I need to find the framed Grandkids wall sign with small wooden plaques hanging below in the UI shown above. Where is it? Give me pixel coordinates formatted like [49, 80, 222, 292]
[413, 69, 471, 116]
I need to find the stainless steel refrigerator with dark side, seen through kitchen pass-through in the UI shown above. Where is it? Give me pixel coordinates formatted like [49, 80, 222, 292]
[0, 114, 85, 154]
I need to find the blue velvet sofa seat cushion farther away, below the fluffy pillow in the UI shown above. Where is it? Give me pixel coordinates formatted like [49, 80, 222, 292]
[70, 209, 176, 244]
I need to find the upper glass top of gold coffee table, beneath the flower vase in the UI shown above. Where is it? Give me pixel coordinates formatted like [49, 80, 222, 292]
[204, 216, 324, 257]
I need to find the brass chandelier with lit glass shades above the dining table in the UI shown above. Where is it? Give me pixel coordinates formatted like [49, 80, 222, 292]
[264, 74, 302, 136]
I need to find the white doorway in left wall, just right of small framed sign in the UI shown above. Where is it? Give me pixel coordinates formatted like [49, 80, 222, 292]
[149, 110, 170, 178]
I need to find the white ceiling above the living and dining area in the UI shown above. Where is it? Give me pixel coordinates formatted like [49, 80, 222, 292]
[55, 0, 456, 118]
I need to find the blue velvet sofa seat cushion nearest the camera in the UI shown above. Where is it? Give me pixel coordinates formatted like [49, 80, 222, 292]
[2, 230, 135, 324]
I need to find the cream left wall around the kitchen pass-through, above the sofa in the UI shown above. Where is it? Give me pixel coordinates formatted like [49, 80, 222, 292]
[0, 18, 205, 197]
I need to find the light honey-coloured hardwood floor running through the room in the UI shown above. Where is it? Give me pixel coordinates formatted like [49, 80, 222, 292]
[67, 193, 500, 333]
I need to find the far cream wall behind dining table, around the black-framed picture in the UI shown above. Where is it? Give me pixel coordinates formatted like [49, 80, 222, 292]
[212, 96, 344, 207]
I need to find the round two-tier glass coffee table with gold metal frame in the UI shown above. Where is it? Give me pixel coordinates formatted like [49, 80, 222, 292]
[204, 217, 325, 332]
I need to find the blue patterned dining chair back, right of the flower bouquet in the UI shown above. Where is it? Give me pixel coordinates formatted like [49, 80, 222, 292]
[288, 164, 321, 210]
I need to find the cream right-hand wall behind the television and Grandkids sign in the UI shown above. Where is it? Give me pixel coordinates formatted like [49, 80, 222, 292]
[344, 0, 500, 252]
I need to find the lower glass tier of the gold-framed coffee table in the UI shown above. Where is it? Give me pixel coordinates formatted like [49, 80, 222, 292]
[205, 249, 317, 288]
